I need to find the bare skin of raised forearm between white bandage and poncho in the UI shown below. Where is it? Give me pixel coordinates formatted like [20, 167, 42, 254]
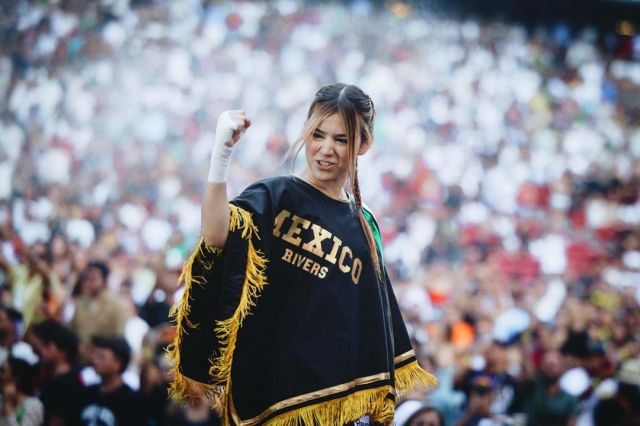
[202, 182, 229, 247]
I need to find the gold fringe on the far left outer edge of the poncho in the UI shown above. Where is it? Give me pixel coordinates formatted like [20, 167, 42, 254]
[167, 238, 222, 404]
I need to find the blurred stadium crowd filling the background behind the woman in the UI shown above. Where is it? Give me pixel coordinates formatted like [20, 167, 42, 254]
[0, 0, 640, 426]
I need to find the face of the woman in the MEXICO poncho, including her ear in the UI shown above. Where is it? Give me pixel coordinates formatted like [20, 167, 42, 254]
[305, 113, 369, 193]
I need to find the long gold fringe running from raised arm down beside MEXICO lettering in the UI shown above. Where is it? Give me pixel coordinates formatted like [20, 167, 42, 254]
[209, 205, 267, 424]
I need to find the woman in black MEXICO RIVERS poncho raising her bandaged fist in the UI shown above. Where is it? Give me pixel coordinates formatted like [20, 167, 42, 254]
[170, 84, 435, 425]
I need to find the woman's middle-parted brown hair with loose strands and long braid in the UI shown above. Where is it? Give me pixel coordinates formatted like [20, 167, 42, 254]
[290, 83, 382, 279]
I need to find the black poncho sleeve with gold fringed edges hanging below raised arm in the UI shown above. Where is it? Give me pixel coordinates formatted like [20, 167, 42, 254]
[168, 204, 266, 412]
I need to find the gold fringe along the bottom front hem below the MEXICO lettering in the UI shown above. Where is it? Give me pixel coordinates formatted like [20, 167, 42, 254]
[260, 386, 395, 426]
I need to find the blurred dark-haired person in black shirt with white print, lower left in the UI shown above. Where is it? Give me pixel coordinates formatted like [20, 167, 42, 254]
[80, 337, 146, 426]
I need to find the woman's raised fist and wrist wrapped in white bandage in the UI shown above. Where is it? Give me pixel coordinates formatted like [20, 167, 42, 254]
[208, 109, 251, 183]
